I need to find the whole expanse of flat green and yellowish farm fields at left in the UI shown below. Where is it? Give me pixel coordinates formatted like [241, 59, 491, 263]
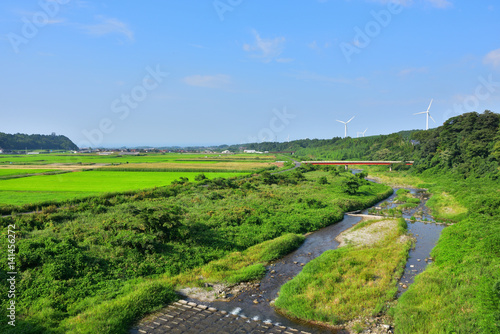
[0, 153, 277, 205]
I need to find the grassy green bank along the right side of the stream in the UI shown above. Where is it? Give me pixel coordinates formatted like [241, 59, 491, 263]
[364, 170, 500, 333]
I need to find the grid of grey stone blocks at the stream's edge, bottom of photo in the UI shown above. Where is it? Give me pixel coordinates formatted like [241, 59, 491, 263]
[129, 300, 310, 334]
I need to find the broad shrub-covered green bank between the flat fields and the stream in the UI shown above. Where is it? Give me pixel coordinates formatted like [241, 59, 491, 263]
[0, 166, 392, 333]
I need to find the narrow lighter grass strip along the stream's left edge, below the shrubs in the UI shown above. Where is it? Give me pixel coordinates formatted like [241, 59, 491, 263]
[60, 234, 305, 334]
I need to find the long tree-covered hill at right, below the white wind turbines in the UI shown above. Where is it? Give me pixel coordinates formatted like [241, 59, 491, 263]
[235, 110, 500, 177]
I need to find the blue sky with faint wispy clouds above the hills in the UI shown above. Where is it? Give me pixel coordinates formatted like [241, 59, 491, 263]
[0, 0, 500, 147]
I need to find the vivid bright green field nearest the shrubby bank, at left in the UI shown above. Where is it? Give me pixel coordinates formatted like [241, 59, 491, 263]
[0, 171, 244, 205]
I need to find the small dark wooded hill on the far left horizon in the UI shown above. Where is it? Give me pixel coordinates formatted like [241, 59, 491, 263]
[0, 132, 78, 150]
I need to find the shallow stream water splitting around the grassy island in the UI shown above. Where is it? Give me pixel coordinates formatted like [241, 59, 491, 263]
[186, 177, 445, 333]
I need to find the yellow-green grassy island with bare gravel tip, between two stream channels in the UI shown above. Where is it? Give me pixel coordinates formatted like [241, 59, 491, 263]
[275, 218, 411, 325]
